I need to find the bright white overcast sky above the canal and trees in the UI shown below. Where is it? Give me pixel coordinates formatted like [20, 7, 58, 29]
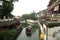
[12, 0, 49, 16]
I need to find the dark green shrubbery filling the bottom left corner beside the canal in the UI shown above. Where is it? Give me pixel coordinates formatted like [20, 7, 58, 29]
[0, 29, 17, 40]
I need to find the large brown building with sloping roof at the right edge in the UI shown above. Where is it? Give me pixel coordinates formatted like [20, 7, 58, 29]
[46, 0, 60, 20]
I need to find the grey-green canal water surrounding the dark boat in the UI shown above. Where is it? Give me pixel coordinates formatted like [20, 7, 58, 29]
[17, 28, 39, 40]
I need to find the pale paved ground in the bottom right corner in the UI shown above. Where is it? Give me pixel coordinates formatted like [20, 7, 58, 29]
[48, 26, 60, 40]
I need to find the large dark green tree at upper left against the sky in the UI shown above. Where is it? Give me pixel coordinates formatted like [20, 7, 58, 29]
[0, 0, 18, 17]
